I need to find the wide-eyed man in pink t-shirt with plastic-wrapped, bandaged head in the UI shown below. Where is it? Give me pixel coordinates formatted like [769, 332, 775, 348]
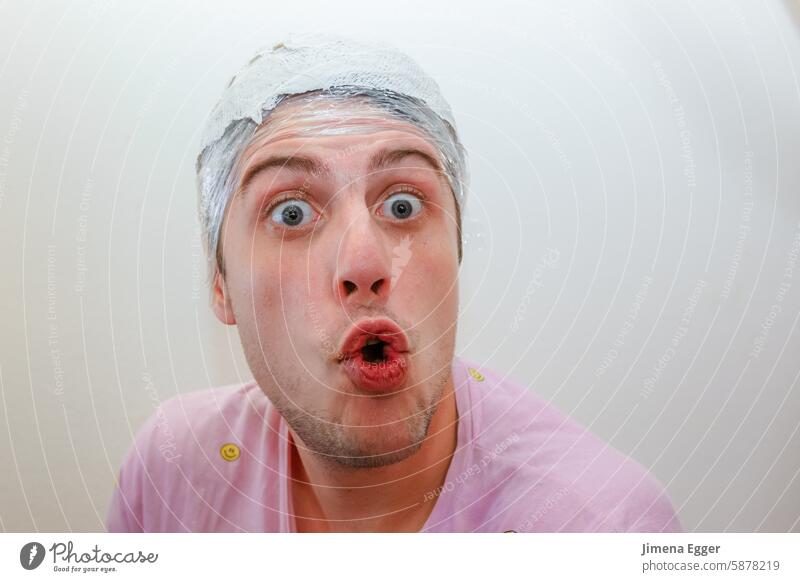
[108, 32, 680, 532]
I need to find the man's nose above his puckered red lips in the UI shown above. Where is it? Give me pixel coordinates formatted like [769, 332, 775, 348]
[335, 211, 392, 307]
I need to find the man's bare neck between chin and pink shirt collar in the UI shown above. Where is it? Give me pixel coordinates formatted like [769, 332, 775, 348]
[289, 377, 458, 531]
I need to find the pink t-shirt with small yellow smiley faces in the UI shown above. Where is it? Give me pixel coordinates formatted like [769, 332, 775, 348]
[107, 358, 681, 532]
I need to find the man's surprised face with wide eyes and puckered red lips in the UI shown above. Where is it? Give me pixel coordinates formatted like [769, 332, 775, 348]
[213, 96, 458, 467]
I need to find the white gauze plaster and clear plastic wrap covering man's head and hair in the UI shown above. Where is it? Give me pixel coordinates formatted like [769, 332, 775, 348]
[197, 35, 468, 276]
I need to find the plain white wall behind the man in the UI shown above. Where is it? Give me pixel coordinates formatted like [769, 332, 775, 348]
[0, 0, 800, 531]
